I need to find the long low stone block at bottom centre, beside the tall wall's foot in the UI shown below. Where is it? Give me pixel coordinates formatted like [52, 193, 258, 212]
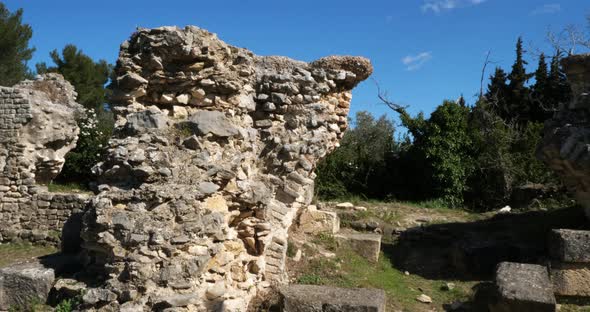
[280, 285, 386, 312]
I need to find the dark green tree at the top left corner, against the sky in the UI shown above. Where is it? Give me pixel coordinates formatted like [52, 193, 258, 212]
[0, 2, 35, 86]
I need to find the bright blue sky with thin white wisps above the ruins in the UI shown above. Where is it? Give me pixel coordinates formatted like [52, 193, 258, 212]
[3, 0, 590, 125]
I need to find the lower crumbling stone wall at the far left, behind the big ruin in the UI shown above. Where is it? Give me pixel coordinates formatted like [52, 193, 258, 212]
[0, 74, 87, 244]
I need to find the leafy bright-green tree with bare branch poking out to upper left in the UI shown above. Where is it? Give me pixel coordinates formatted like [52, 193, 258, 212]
[379, 94, 473, 207]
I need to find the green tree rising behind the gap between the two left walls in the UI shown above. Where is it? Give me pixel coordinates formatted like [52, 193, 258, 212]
[36, 44, 112, 109]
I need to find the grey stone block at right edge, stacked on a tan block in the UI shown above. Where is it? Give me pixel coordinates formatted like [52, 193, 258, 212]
[549, 230, 590, 263]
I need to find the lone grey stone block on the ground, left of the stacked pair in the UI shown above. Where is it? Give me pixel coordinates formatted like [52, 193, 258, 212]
[489, 262, 556, 312]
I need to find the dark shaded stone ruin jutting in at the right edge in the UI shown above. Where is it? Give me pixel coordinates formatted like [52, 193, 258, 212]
[537, 54, 590, 217]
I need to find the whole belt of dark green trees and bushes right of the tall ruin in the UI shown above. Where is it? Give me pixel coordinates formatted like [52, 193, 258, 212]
[317, 38, 571, 211]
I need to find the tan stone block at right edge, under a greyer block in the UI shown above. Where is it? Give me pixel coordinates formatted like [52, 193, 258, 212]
[551, 263, 590, 297]
